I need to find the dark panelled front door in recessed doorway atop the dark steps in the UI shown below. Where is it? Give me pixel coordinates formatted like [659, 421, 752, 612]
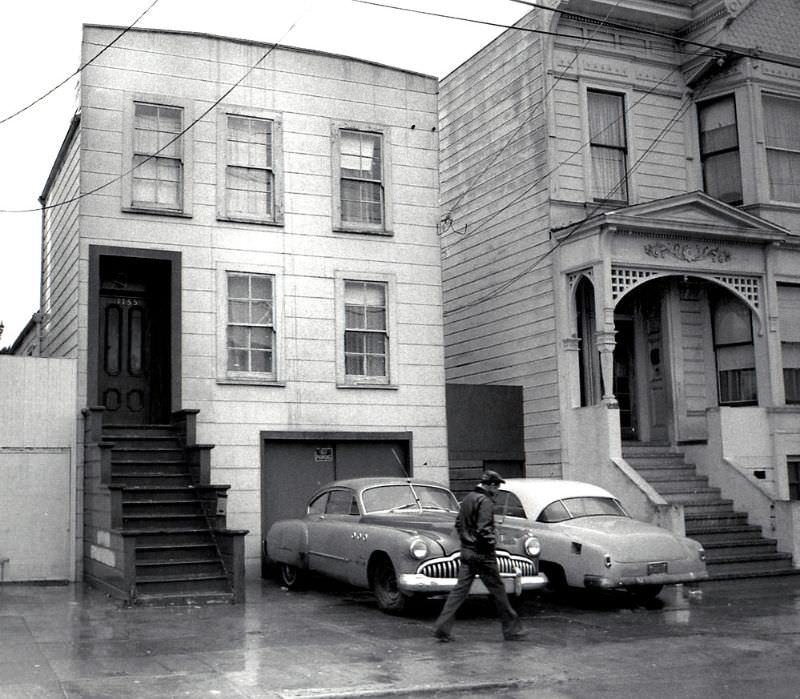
[97, 258, 169, 424]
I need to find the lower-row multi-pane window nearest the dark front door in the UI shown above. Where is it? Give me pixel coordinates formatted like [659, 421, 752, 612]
[226, 272, 275, 376]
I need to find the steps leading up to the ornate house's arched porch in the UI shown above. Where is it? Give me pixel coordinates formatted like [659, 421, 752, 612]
[623, 445, 800, 580]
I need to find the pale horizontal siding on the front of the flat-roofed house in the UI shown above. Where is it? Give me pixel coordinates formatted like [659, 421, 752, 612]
[68, 26, 447, 571]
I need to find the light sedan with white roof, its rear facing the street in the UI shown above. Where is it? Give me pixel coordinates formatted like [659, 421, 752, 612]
[495, 478, 708, 600]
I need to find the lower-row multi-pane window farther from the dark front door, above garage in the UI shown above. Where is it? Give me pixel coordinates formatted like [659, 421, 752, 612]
[344, 280, 389, 383]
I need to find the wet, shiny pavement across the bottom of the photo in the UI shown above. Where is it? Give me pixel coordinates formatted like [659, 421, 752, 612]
[0, 576, 800, 699]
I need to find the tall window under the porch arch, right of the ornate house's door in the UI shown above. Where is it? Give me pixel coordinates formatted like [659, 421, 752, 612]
[713, 294, 758, 405]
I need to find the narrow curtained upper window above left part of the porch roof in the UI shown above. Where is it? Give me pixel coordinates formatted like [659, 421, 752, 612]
[586, 90, 628, 203]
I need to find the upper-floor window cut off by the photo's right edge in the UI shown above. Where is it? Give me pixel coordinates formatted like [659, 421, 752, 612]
[763, 95, 800, 202]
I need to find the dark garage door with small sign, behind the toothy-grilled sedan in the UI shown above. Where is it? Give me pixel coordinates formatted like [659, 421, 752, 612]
[261, 433, 411, 572]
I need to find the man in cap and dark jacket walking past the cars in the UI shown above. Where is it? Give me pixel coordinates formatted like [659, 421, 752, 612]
[433, 471, 527, 641]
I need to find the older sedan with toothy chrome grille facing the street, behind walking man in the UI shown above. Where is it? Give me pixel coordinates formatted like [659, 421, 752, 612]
[266, 477, 547, 614]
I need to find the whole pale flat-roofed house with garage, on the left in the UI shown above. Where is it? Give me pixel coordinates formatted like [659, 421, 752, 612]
[31, 25, 447, 597]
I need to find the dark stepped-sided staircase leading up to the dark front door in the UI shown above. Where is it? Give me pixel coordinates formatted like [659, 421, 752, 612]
[86, 408, 246, 604]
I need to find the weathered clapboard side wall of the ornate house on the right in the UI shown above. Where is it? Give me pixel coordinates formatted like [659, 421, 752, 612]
[440, 12, 559, 476]
